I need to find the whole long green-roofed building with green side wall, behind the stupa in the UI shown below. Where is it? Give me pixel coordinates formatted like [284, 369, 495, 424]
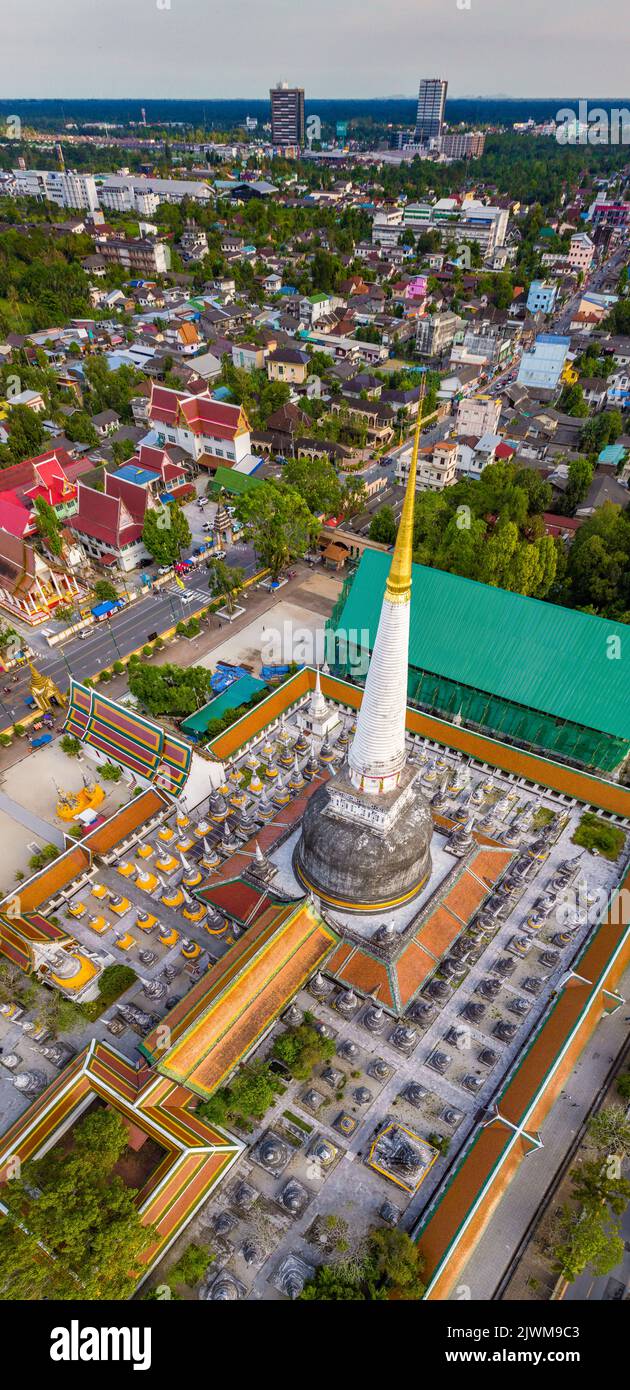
[328, 550, 630, 771]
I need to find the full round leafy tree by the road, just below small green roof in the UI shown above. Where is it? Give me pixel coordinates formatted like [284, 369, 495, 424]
[236, 482, 320, 580]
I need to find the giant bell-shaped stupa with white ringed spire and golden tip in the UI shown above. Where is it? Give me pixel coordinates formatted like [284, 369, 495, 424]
[293, 411, 433, 913]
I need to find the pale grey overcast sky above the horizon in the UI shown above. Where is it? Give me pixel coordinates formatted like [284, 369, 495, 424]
[1, 0, 630, 99]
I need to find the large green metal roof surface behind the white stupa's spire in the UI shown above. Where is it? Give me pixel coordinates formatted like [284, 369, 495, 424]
[337, 550, 630, 739]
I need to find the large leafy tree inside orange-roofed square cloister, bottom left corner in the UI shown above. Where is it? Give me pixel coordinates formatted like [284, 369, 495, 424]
[0, 1109, 156, 1300]
